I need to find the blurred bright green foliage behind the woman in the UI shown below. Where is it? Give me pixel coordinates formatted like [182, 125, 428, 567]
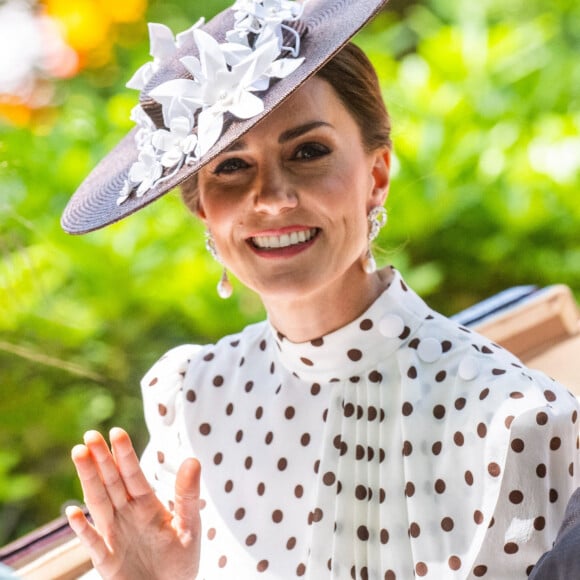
[0, 0, 580, 544]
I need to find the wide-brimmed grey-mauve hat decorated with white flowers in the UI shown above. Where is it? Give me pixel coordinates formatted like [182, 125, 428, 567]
[61, 0, 387, 234]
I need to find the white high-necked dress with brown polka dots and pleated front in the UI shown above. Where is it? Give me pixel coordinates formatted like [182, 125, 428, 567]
[142, 272, 579, 580]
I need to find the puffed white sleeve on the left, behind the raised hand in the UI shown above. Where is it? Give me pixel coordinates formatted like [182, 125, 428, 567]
[141, 345, 203, 507]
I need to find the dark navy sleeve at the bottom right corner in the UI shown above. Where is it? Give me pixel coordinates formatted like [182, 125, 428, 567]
[530, 488, 580, 580]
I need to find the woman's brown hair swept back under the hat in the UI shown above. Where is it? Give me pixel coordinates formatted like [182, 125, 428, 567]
[180, 42, 391, 212]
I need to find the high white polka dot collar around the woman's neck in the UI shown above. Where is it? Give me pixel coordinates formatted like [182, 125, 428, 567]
[271, 270, 431, 383]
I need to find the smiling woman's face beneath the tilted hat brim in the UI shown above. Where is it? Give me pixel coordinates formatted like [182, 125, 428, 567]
[198, 77, 390, 302]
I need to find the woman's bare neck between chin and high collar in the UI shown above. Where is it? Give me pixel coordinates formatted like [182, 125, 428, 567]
[262, 268, 393, 343]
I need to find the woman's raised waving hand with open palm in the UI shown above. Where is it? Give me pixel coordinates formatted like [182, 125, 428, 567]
[66, 428, 201, 580]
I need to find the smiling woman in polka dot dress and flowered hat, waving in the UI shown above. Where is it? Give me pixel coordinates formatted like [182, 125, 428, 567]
[63, 0, 578, 579]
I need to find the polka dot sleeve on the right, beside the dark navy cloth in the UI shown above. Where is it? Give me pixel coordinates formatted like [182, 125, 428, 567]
[472, 391, 580, 580]
